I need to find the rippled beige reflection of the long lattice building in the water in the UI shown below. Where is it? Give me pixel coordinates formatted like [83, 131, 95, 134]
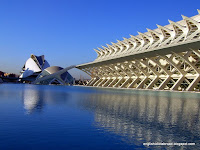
[80, 91, 200, 148]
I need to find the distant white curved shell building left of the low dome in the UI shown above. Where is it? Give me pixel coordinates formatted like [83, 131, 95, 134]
[20, 54, 50, 80]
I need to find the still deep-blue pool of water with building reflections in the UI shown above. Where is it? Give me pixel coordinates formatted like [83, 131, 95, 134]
[0, 84, 200, 150]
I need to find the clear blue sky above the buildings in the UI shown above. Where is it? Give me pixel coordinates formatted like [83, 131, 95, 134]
[0, 0, 200, 77]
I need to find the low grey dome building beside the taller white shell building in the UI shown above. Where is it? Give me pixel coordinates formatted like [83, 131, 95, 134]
[35, 66, 74, 85]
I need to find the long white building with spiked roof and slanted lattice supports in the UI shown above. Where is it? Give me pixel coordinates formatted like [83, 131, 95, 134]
[77, 10, 200, 91]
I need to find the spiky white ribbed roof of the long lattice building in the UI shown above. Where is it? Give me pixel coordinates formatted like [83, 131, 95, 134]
[88, 10, 200, 62]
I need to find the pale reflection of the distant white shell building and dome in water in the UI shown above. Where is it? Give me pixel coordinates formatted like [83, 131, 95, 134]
[22, 85, 68, 113]
